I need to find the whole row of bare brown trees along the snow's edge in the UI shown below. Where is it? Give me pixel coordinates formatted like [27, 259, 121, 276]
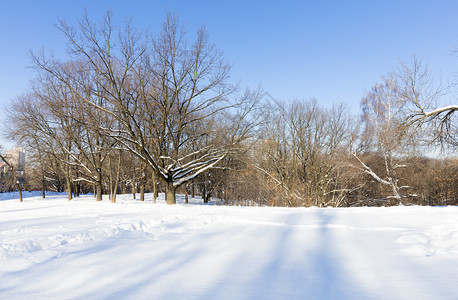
[3, 14, 458, 207]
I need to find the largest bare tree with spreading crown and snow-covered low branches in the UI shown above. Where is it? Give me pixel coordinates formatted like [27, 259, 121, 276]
[33, 13, 255, 204]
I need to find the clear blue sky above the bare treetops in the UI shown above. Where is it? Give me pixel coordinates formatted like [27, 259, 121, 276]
[0, 0, 458, 146]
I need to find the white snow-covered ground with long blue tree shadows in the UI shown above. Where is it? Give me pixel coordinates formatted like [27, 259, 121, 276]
[0, 193, 458, 299]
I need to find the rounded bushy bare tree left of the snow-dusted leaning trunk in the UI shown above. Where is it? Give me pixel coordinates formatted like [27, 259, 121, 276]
[254, 101, 356, 206]
